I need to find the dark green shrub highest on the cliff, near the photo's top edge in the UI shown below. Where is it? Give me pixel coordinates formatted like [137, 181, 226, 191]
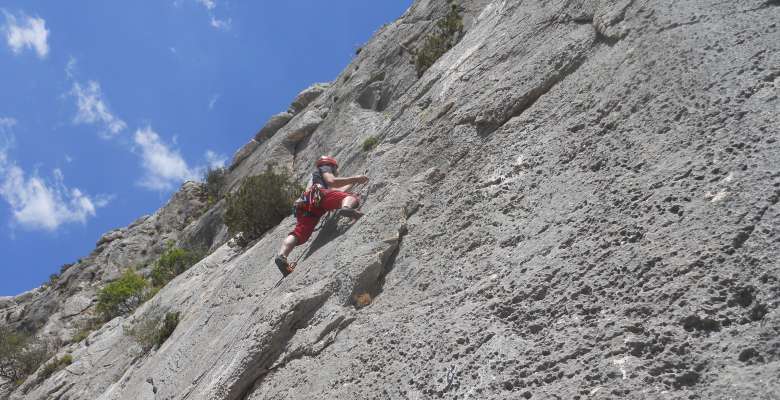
[412, 1, 463, 78]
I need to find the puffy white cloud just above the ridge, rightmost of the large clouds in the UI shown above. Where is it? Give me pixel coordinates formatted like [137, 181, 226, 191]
[135, 126, 198, 190]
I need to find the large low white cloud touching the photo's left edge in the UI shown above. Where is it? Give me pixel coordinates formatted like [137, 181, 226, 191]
[0, 140, 109, 231]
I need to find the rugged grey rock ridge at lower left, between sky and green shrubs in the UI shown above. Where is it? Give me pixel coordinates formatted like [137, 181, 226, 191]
[0, 182, 206, 342]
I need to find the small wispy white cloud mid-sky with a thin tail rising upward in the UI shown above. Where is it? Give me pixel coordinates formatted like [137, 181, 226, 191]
[66, 79, 127, 139]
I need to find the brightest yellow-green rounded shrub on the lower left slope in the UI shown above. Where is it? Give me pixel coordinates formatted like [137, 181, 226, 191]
[96, 269, 148, 321]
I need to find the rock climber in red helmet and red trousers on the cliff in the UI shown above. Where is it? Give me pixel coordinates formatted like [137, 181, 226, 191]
[274, 156, 368, 276]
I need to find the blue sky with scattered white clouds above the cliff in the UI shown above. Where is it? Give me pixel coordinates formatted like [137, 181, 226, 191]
[0, 0, 411, 296]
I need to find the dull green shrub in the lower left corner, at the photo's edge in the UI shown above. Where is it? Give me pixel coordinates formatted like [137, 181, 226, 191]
[0, 327, 51, 386]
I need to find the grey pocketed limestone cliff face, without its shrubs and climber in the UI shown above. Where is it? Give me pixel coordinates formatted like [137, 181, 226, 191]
[0, 0, 780, 400]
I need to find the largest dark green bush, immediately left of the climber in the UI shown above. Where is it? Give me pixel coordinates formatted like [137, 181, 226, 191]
[223, 166, 303, 242]
